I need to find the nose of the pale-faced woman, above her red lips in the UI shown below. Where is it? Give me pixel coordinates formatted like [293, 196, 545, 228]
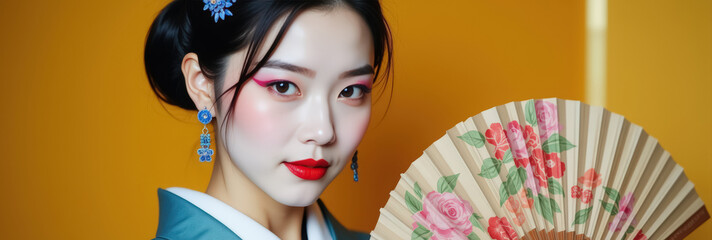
[297, 98, 336, 145]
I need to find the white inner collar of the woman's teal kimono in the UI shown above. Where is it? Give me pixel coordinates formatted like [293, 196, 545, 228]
[166, 187, 332, 240]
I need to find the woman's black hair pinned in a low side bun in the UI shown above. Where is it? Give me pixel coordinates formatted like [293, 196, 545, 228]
[144, 0, 393, 127]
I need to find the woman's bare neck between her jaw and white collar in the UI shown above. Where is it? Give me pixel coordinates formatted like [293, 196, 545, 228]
[206, 137, 305, 240]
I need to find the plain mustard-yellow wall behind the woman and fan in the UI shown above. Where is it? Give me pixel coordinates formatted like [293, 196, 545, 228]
[0, 0, 712, 239]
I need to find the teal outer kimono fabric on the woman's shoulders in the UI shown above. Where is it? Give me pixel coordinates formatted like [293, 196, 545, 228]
[155, 188, 369, 240]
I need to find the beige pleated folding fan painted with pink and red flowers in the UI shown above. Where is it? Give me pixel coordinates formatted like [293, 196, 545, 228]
[371, 98, 709, 240]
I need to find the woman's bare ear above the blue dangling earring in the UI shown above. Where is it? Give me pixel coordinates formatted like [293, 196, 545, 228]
[181, 53, 215, 116]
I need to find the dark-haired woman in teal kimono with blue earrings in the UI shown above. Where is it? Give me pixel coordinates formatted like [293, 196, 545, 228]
[144, 0, 392, 240]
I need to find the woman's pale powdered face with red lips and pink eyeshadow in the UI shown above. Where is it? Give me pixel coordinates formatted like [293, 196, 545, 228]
[217, 7, 373, 206]
